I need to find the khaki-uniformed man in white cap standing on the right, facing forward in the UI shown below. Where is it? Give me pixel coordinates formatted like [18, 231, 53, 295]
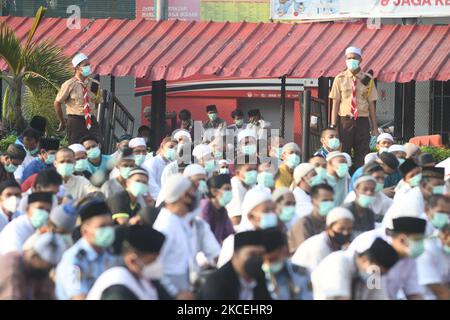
[329, 47, 378, 168]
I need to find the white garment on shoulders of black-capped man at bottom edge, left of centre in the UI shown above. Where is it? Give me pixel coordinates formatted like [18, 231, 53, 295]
[86, 267, 158, 300]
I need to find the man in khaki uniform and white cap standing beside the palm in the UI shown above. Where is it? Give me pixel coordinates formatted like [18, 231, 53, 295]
[54, 53, 102, 144]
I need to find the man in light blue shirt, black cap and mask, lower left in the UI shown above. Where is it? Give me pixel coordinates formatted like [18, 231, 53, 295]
[55, 199, 119, 300]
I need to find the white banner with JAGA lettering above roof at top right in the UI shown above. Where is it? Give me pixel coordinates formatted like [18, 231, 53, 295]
[270, 0, 450, 20]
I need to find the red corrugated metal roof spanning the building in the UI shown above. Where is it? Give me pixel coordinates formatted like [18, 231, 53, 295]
[0, 17, 450, 82]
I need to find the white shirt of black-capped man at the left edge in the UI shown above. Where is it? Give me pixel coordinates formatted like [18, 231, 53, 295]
[0, 214, 36, 255]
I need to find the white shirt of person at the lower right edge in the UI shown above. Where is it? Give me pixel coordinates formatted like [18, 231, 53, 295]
[416, 238, 450, 300]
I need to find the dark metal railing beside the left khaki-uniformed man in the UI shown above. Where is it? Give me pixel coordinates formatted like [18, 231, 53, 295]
[98, 90, 135, 154]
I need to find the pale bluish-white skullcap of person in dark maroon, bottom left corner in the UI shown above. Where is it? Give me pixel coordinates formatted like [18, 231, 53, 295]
[32, 232, 68, 265]
